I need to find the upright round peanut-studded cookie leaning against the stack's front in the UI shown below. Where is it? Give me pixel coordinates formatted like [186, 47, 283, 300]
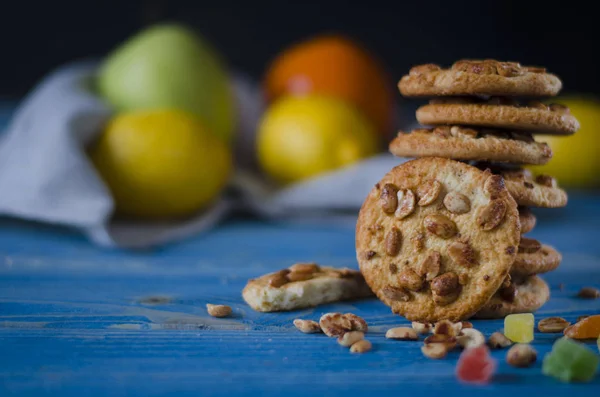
[356, 157, 520, 322]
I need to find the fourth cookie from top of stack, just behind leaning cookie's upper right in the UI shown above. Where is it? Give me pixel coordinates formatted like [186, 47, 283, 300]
[476, 163, 568, 208]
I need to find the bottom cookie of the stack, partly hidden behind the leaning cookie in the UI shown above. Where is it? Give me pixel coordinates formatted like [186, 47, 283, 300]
[473, 276, 550, 318]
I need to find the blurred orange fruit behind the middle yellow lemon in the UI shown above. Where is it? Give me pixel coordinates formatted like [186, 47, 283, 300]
[264, 36, 394, 136]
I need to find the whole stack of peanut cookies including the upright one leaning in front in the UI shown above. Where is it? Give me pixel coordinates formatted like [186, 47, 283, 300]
[356, 60, 579, 321]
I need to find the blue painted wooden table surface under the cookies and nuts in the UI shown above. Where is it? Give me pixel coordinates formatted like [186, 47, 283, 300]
[0, 193, 600, 396]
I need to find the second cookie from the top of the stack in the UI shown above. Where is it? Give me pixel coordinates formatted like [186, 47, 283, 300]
[417, 98, 579, 135]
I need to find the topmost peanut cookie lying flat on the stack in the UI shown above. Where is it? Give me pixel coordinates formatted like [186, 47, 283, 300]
[398, 59, 562, 97]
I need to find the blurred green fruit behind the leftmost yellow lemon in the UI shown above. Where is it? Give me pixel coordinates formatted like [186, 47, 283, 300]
[98, 25, 235, 141]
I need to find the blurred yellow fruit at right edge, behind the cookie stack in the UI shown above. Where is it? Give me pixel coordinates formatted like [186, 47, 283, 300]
[531, 96, 600, 187]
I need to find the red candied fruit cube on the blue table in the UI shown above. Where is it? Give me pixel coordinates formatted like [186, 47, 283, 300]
[456, 345, 496, 385]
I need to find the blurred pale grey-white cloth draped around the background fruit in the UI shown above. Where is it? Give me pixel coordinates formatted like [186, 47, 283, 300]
[0, 63, 402, 248]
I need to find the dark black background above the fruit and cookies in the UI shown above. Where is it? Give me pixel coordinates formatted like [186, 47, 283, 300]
[0, 0, 600, 98]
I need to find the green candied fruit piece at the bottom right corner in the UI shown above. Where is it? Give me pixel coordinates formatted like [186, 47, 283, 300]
[542, 337, 600, 382]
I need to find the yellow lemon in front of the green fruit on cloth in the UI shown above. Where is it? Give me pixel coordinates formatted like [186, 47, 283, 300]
[90, 109, 232, 219]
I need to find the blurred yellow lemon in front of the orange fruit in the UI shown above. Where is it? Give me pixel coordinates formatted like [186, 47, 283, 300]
[257, 95, 377, 183]
